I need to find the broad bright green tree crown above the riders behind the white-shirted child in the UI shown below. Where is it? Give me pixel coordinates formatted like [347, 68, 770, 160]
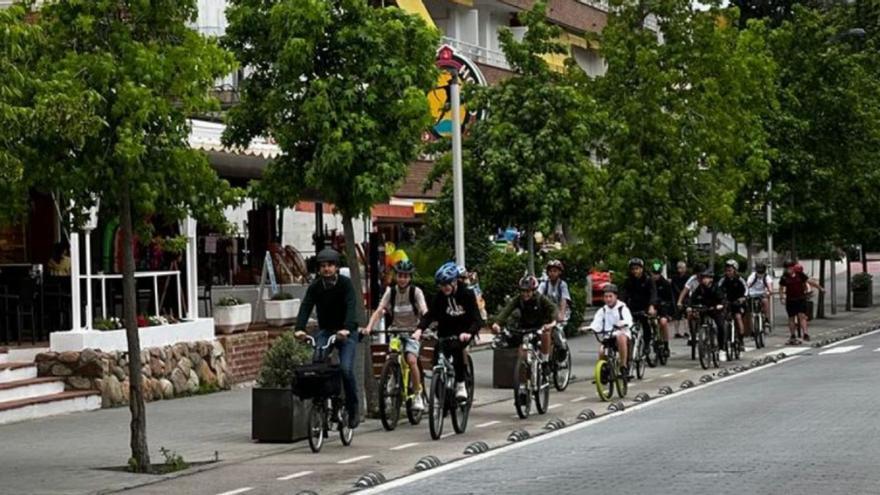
[589, 0, 774, 264]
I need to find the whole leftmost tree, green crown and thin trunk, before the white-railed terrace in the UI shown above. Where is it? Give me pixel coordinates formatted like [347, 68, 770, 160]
[0, 0, 236, 471]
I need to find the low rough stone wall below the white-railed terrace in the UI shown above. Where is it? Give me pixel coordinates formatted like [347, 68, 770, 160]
[36, 341, 230, 407]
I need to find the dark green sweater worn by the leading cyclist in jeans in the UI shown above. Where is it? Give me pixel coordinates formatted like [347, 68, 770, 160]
[296, 275, 358, 335]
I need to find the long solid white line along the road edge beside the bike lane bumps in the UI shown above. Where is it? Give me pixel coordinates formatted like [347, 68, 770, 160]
[358, 356, 800, 495]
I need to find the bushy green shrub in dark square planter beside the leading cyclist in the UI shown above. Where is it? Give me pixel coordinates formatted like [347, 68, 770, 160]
[251, 331, 312, 442]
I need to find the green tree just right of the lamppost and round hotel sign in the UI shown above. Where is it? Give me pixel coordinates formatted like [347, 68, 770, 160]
[434, 0, 600, 273]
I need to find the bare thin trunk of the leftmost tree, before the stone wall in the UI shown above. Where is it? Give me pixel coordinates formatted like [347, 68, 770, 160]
[119, 178, 151, 473]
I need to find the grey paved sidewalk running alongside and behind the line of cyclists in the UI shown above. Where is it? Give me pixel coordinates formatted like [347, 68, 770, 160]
[0, 307, 880, 494]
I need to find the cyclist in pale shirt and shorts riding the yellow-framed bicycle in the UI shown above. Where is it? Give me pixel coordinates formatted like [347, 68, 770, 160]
[364, 260, 428, 411]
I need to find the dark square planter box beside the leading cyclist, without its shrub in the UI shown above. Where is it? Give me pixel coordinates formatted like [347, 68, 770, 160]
[251, 387, 312, 442]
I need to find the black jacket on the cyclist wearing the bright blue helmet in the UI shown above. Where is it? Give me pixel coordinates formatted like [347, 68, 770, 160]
[418, 284, 483, 337]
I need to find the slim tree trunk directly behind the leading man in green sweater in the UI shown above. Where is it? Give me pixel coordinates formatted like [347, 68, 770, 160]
[342, 213, 379, 419]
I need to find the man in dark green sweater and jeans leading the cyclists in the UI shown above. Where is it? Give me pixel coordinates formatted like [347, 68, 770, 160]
[294, 248, 360, 429]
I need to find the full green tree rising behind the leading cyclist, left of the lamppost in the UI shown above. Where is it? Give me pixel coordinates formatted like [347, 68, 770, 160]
[224, 0, 439, 409]
